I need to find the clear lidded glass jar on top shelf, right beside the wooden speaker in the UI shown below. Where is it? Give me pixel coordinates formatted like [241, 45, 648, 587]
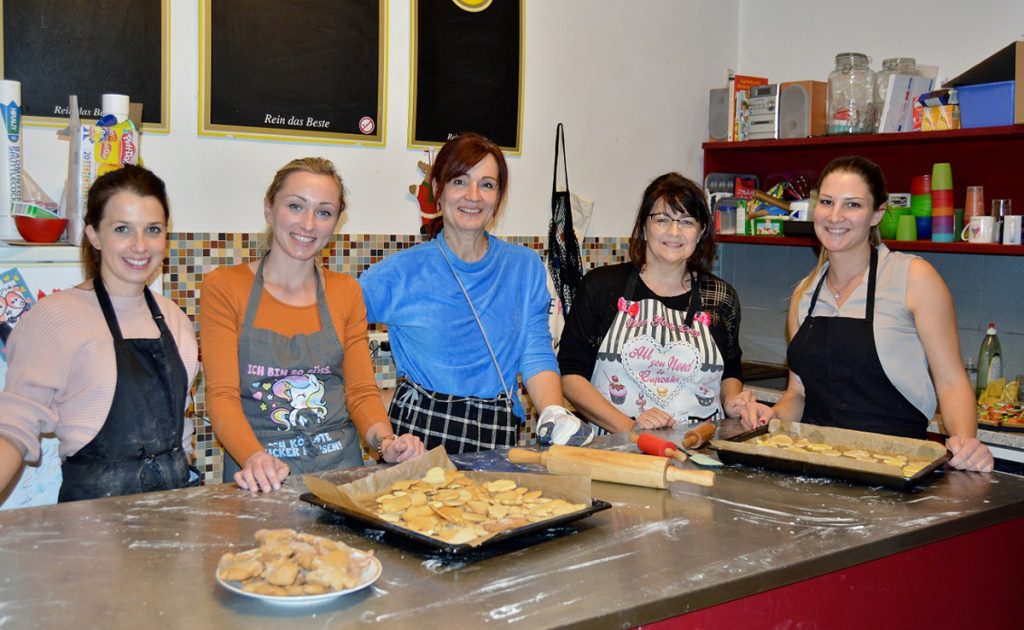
[828, 52, 874, 135]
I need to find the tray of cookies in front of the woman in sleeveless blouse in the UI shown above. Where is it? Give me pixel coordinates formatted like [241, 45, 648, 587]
[711, 418, 951, 492]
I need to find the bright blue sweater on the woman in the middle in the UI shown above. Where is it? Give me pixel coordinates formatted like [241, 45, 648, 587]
[359, 230, 558, 418]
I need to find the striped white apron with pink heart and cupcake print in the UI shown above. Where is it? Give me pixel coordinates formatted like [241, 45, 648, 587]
[590, 270, 725, 422]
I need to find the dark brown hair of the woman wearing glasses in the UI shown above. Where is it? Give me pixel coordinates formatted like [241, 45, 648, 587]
[630, 173, 715, 280]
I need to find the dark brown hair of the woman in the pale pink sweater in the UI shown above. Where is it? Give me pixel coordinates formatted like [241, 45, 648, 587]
[82, 164, 171, 280]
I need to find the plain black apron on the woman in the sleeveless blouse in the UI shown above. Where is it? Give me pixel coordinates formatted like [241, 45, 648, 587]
[786, 248, 928, 439]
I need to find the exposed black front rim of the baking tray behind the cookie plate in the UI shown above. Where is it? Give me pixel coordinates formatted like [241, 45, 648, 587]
[299, 492, 611, 555]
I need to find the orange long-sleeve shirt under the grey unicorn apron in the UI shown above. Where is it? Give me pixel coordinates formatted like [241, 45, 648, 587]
[199, 264, 387, 464]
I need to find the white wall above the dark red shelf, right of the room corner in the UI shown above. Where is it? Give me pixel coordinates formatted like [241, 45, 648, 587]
[738, 0, 1024, 83]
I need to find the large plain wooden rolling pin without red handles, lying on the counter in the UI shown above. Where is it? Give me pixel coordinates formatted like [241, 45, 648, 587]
[509, 446, 715, 488]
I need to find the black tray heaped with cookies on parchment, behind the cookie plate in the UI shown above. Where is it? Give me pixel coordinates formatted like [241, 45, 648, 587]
[301, 449, 611, 554]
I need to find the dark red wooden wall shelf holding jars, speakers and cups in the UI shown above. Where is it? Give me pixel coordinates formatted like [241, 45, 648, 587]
[703, 125, 1024, 256]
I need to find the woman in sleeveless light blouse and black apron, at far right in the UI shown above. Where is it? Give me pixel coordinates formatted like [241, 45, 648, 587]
[775, 156, 992, 471]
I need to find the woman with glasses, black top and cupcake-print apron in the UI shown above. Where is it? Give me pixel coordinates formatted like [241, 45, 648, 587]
[558, 173, 774, 431]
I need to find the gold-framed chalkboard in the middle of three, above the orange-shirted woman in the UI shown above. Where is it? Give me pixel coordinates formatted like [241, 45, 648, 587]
[201, 0, 386, 144]
